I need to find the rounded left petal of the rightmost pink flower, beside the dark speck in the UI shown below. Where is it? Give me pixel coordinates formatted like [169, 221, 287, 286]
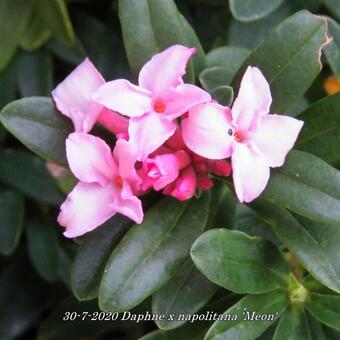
[182, 103, 233, 159]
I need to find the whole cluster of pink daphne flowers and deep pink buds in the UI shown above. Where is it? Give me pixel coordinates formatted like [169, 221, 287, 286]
[52, 45, 303, 237]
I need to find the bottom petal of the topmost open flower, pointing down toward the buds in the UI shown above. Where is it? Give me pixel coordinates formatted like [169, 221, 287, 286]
[129, 113, 177, 161]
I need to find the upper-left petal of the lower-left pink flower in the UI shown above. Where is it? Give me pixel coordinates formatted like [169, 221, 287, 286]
[66, 133, 118, 186]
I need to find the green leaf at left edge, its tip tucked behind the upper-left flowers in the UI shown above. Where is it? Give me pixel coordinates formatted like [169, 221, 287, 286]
[0, 97, 73, 166]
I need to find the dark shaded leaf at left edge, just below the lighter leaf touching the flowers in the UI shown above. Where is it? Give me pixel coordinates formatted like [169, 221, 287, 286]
[0, 150, 63, 205]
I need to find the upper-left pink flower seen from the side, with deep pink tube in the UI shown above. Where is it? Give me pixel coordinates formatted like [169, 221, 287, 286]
[52, 58, 128, 134]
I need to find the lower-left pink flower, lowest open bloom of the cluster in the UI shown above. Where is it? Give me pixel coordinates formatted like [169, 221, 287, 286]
[58, 133, 143, 237]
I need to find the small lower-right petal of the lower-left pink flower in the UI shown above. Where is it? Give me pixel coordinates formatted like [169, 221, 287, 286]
[110, 182, 144, 223]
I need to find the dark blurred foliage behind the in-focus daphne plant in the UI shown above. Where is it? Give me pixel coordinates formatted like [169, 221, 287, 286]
[0, 0, 340, 340]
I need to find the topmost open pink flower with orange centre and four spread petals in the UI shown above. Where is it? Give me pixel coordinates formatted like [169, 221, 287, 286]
[92, 45, 211, 160]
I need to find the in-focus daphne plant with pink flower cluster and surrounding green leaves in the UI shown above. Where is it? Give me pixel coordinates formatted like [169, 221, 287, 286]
[0, 0, 340, 340]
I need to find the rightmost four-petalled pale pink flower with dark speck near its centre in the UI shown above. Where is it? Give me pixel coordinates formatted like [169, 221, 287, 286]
[182, 67, 303, 202]
